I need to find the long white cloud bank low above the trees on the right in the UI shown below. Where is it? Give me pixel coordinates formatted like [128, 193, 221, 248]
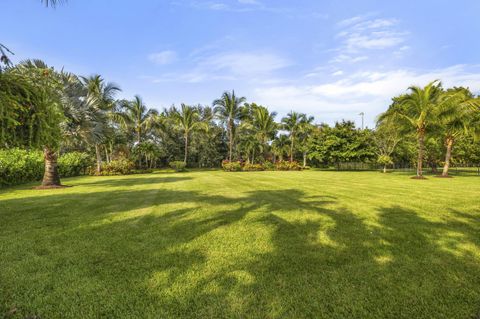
[253, 65, 480, 126]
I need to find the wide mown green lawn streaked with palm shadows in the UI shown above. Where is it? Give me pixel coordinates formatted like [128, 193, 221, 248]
[0, 171, 480, 318]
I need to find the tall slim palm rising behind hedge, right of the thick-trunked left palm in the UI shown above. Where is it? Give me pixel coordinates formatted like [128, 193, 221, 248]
[81, 74, 121, 173]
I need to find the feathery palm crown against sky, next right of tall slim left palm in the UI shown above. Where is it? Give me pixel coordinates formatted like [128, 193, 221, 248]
[113, 95, 159, 144]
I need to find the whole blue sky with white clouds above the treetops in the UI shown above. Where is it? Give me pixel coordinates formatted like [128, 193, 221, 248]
[0, 0, 480, 126]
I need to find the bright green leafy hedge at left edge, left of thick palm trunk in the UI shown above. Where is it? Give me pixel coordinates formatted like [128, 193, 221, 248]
[0, 148, 44, 186]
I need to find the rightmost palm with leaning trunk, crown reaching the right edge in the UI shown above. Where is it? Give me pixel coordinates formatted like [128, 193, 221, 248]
[438, 88, 480, 177]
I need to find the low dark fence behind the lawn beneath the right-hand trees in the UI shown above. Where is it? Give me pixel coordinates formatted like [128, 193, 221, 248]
[333, 162, 480, 176]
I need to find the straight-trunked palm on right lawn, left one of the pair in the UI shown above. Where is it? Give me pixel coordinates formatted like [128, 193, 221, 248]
[379, 80, 442, 179]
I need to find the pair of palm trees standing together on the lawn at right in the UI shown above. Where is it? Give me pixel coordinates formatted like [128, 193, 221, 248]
[378, 80, 480, 179]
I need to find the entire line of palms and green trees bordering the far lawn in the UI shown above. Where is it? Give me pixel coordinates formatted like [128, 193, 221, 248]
[0, 60, 480, 186]
